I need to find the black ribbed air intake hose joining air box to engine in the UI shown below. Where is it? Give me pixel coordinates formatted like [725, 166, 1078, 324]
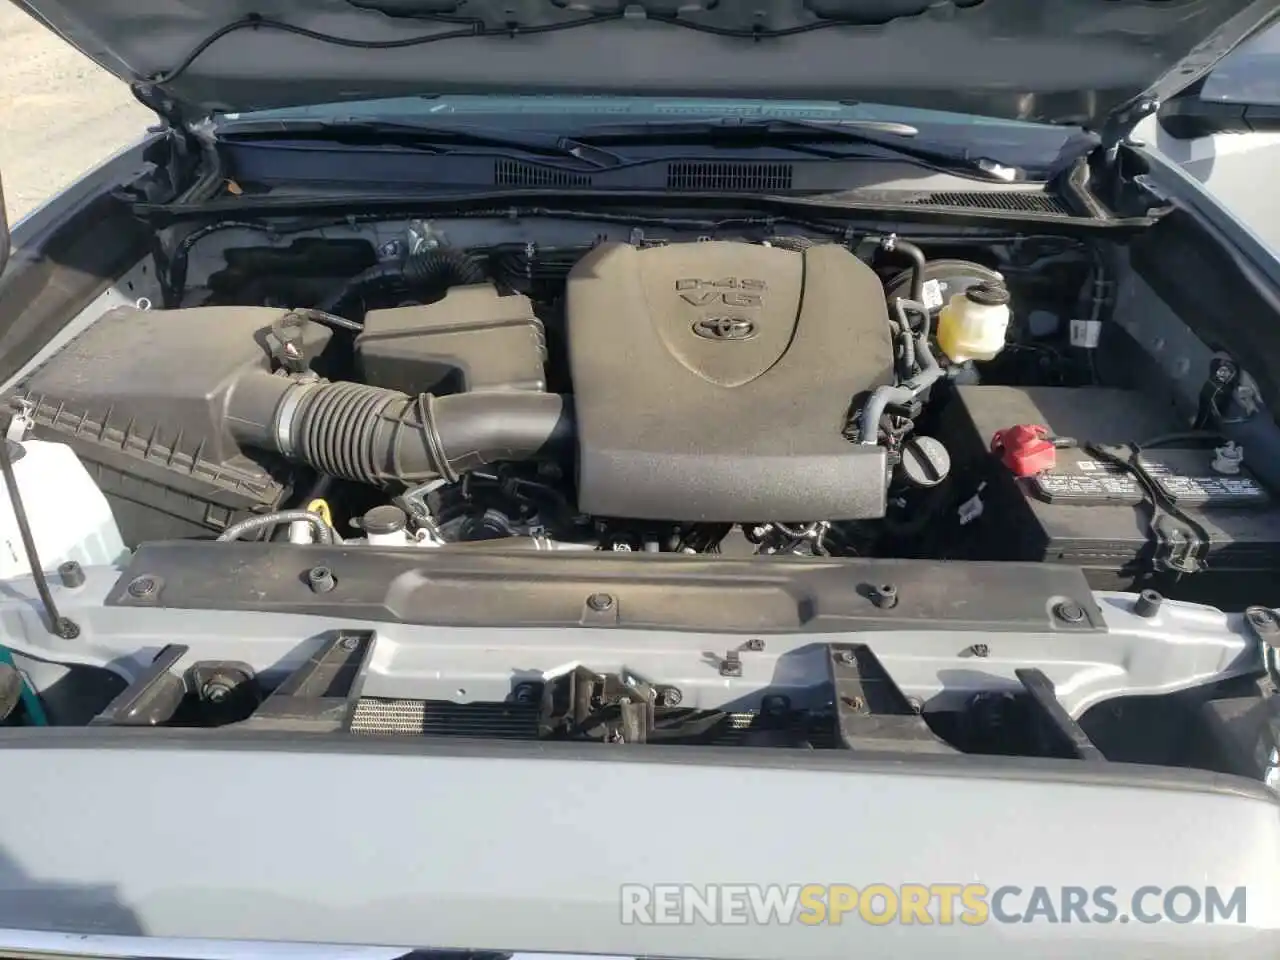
[228, 372, 573, 486]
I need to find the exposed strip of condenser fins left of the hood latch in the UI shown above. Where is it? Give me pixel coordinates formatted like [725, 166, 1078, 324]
[351, 696, 538, 740]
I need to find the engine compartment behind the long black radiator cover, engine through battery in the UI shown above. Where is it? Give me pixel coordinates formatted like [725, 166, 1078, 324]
[12, 221, 1280, 605]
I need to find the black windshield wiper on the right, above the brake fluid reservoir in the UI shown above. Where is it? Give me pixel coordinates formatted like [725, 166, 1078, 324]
[573, 116, 1021, 182]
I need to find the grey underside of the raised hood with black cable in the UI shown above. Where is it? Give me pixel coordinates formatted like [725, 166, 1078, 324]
[7, 0, 1280, 128]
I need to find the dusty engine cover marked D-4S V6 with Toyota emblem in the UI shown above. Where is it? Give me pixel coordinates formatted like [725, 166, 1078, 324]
[567, 242, 893, 522]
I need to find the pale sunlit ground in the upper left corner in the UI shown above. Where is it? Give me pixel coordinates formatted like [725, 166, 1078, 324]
[0, 0, 155, 220]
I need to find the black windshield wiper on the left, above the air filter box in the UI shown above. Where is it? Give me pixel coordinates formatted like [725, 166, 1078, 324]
[215, 116, 626, 169]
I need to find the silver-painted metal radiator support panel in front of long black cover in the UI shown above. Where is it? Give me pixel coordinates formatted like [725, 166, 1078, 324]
[0, 567, 1261, 718]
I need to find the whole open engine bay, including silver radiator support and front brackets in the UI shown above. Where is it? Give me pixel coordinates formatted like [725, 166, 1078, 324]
[0, 204, 1280, 777]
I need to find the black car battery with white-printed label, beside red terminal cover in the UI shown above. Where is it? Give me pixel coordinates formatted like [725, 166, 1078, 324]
[945, 385, 1280, 599]
